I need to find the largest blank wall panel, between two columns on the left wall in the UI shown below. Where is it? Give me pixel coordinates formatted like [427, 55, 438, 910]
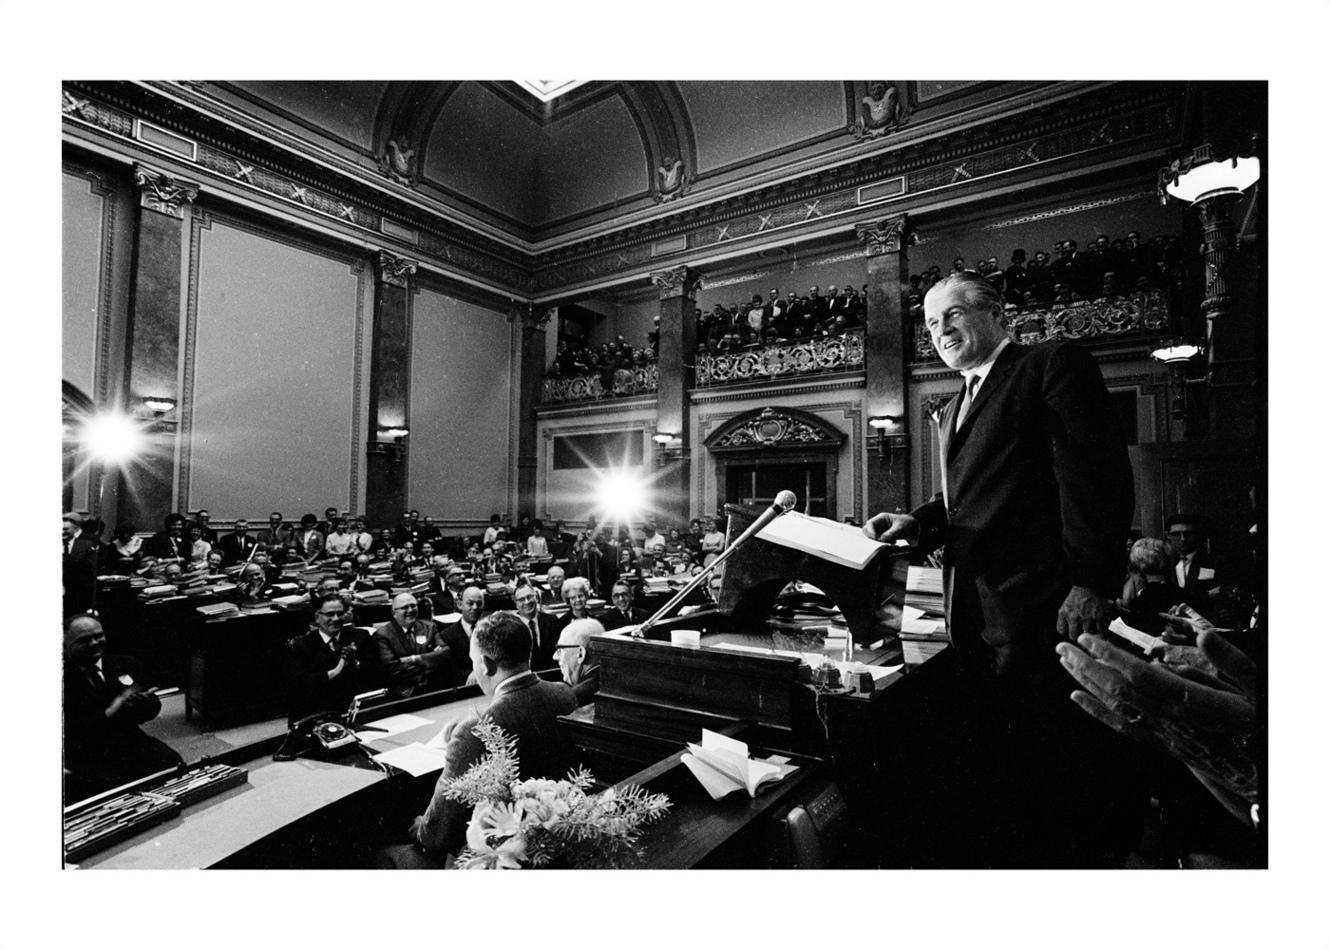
[188, 221, 363, 519]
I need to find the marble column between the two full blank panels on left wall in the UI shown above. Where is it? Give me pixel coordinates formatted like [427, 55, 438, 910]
[364, 250, 416, 530]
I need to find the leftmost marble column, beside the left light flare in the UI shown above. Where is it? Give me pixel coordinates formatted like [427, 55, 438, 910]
[117, 165, 198, 531]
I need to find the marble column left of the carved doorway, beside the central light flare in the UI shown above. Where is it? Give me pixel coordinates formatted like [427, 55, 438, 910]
[648, 266, 701, 526]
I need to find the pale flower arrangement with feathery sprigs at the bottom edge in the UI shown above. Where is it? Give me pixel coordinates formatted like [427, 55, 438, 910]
[444, 718, 669, 870]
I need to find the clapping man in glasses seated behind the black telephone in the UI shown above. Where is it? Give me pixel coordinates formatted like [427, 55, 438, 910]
[287, 592, 379, 725]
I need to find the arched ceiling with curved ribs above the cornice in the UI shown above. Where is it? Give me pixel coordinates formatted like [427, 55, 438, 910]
[207, 80, 862, 241]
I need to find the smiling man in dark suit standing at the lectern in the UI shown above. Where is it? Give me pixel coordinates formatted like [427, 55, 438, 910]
[865, 273, 1142, 868]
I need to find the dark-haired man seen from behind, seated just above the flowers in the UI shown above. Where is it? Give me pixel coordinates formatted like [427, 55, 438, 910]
[395, 611, 577, 866]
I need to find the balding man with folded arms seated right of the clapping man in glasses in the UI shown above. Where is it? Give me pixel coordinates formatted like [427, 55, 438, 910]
[374, 593, 468, 699]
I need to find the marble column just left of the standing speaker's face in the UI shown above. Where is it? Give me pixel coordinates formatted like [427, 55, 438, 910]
[854, 214, 927, 518]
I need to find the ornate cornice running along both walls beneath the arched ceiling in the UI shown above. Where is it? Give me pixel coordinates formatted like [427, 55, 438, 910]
[61, 81, 1178, 298]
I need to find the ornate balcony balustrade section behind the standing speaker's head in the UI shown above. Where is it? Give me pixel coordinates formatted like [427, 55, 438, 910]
[914, 290, 1169, 363]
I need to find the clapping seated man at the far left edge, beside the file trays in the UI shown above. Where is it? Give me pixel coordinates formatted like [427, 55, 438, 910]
[64, 613, 182, 804]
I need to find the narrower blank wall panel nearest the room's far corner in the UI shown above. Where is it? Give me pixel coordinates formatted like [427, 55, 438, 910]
[407, 290, 512, 522]
